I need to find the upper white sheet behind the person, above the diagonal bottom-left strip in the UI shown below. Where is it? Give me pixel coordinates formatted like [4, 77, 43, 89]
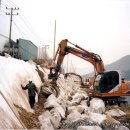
[0, 56, 41, 112]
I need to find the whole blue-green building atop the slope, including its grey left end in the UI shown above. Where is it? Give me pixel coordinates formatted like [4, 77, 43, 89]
[1, 39, 38, 61]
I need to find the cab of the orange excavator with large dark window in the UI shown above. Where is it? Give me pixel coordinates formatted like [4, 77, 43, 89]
[94, 71, 120, 93]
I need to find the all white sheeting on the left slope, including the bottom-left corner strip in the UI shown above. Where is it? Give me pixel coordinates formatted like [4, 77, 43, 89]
[0, 56, 41, 129]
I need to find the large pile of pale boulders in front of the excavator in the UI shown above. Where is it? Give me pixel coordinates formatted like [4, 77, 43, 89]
[38, 72, 128, 130]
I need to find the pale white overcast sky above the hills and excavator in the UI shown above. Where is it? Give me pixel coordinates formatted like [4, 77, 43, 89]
[0, 0, 130, 71]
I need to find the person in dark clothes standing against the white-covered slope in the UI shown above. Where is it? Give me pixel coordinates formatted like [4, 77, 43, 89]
[21, 81, 38, 109]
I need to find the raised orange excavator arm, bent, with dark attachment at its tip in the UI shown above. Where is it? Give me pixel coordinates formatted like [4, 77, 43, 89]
[48, 39, 105, 79]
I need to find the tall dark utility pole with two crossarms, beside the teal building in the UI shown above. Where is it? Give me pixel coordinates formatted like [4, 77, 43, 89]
[6, 7, 19, 54]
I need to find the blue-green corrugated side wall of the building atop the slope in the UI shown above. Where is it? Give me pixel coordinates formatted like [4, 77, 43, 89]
[19, 39, 38, 60]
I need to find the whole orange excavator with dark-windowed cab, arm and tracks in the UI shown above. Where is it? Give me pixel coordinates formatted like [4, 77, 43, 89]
[48, 39, 130, 105]
